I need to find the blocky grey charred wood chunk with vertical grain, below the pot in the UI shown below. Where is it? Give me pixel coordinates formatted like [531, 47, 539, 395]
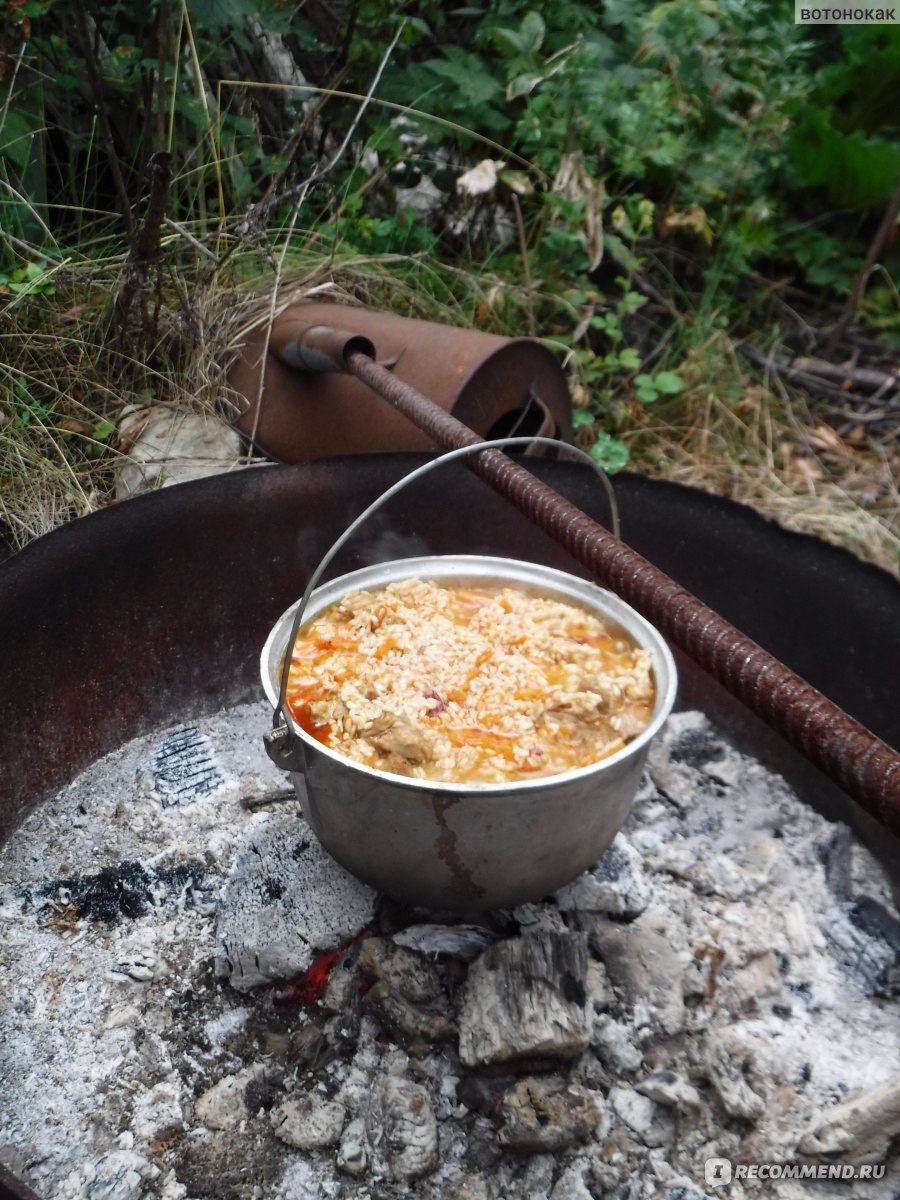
[458, 932, 593, 1067]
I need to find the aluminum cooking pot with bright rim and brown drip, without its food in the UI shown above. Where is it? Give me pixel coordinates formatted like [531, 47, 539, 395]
[260, 554, 677, 910]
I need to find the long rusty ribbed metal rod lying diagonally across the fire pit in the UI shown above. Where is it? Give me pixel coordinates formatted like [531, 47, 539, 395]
[336, 350, 900, 835]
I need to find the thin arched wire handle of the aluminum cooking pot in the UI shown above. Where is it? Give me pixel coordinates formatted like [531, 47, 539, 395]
[265, 436, 619, 739]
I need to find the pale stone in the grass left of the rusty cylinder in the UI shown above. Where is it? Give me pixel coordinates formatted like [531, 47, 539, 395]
[115, 404, 241, 500]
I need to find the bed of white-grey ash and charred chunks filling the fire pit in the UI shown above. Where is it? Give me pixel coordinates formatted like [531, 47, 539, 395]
[0, 706, 900, 1200]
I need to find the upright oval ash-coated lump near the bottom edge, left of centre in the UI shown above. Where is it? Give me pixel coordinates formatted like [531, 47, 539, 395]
[366, 1075, 438, 1181]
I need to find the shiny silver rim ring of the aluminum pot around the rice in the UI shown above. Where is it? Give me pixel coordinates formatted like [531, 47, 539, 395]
[259, 554, 678, 797]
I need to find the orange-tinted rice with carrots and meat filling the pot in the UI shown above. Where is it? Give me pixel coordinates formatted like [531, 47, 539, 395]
[287, 580, 654, 784]
